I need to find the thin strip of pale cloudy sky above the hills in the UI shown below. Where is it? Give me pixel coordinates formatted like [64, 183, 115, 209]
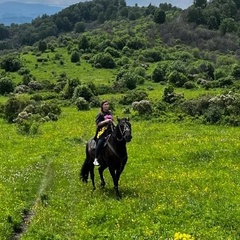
[0, 0, 193, 8]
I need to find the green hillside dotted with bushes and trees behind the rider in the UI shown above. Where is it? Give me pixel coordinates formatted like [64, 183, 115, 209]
[0, 0, 240, 127]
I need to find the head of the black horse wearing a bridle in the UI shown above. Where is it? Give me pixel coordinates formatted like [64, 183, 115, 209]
[117, 118, 132, 142]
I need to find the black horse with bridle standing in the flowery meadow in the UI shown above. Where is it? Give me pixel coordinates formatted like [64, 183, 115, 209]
[80, 118, 132, 198]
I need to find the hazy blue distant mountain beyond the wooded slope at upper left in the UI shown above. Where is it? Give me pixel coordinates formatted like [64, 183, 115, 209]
[0, 2, 63, 25]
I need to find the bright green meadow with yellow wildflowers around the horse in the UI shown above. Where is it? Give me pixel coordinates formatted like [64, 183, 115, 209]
[0, 108, 240, 240]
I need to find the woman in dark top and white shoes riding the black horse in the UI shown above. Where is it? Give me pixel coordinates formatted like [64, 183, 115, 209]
[93, 100, 114, 166]
